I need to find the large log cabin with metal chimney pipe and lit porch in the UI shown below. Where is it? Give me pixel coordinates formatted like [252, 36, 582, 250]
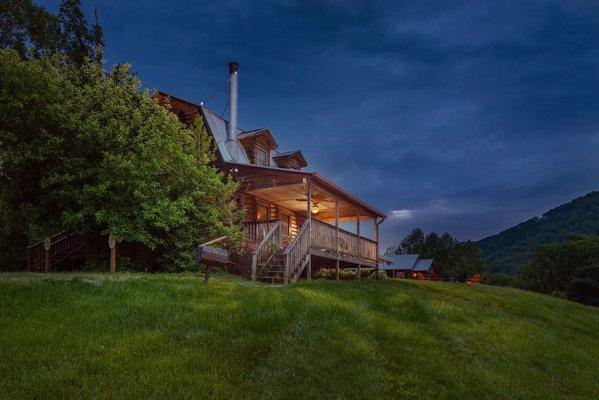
[157, 63, 386, 284]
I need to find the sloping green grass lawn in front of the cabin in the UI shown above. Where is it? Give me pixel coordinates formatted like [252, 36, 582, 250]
[0, 274, 599, 399]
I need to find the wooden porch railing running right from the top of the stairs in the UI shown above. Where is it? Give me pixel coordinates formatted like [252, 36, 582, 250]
[311, 219, 376, 262]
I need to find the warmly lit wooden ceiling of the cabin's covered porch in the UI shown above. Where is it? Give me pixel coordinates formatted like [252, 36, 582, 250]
[246, 183, 372, 222]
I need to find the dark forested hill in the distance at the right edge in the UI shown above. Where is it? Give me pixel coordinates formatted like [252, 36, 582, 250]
[477, 191, 599, 274]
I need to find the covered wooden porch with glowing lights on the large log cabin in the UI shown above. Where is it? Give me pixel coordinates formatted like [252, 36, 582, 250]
[231, 164, 385, 282]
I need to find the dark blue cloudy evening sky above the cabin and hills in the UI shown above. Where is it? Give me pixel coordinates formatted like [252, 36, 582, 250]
[38, 0, 599, 250]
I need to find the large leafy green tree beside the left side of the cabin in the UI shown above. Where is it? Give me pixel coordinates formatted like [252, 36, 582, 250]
[0, 50, 241, 269]
